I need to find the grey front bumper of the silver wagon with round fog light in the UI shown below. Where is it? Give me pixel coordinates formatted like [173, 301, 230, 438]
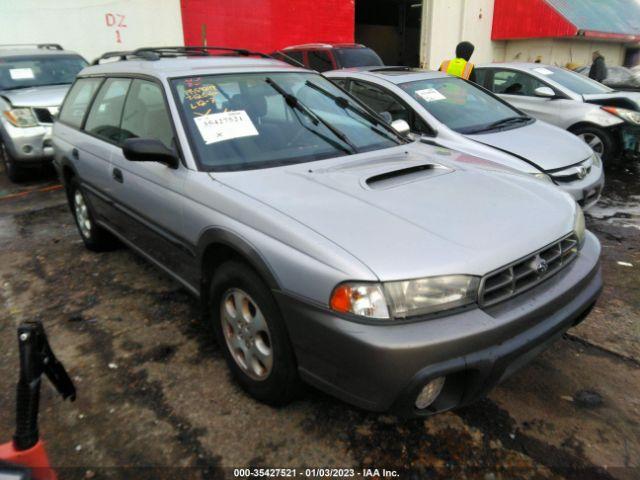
[276, 232, 602, 416]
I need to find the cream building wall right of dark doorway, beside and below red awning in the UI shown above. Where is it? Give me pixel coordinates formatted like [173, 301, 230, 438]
[420, 0, 625, 69]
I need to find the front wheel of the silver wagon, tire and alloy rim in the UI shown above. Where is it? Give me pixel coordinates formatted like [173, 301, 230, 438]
[206, 260, 299, 406]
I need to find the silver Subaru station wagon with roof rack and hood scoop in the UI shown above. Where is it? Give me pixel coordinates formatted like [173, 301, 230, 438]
[54, 47, 602, 416]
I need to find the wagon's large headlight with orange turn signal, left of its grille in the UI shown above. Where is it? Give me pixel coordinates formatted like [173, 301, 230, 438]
[330, 275, 480, 319]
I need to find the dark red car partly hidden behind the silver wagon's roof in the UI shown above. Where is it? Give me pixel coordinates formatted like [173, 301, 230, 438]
[273, 43, 384, 72]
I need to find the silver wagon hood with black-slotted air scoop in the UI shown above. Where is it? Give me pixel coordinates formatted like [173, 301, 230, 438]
[212, 143, 576, 280]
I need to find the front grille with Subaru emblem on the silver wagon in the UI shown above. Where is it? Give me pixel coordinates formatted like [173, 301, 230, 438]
[478, 233, 578, 307]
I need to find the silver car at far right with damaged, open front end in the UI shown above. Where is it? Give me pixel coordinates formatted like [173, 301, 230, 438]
[476, 62, 640, 161]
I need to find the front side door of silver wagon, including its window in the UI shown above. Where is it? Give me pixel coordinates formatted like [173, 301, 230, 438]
[111, 79, 195, 283]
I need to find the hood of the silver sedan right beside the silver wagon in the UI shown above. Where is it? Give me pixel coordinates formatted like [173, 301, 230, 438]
[466, 120, 592, 171]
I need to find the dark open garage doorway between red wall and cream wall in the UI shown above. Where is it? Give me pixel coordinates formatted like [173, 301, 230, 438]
[355, 0, 423, 67]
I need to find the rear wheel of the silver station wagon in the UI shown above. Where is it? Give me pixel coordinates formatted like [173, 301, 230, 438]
[67, 178, 118, 252]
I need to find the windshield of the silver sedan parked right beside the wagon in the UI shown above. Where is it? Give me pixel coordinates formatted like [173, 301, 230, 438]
[399, 77, 528, 133]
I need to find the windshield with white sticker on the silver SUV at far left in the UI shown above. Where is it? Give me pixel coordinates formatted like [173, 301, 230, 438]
[0, 55, 87, 90]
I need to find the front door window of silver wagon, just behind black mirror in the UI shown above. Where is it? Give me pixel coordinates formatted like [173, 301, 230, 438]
[121, 80, 173, 148]
